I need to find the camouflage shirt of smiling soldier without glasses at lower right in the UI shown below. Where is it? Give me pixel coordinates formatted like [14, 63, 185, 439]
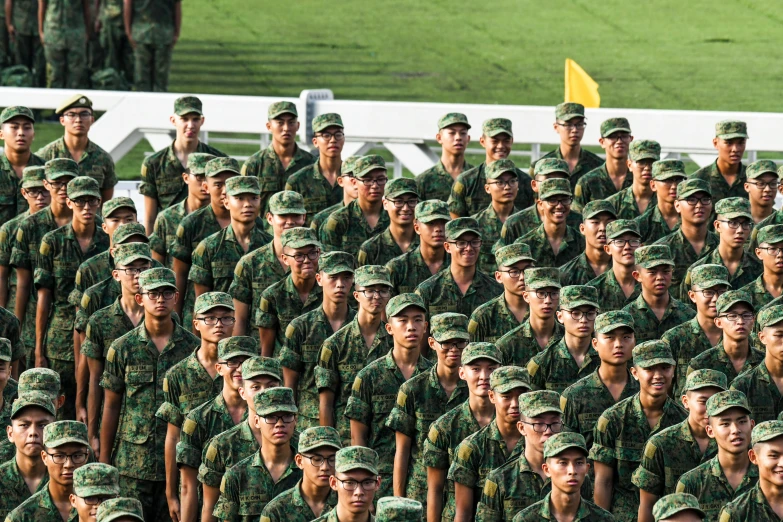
[589, 392, 688, 522]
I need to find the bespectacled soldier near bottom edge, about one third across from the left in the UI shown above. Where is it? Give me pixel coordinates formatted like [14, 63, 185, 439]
[212, 388, 306, 522]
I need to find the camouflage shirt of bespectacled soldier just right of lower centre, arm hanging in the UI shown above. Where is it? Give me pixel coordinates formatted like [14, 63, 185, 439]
[386, 364, 468, 506]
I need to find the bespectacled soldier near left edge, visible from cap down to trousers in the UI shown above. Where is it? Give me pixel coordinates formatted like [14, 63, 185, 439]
[35, 176, 109, 419]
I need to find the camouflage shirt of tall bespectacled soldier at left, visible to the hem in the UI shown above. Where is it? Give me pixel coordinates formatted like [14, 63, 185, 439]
[101, 323, 201, 481]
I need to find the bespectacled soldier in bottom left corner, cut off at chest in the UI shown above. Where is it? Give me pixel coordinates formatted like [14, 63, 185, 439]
[6, 421, 90, 522]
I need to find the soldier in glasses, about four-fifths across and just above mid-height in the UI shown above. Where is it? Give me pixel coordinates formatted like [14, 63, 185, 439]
[586, 219, 642, 312]
